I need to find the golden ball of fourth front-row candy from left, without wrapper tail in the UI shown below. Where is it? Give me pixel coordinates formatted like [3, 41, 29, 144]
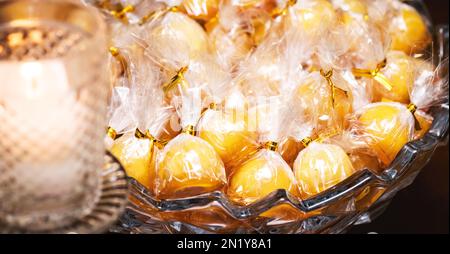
[294, 142, 355, 199]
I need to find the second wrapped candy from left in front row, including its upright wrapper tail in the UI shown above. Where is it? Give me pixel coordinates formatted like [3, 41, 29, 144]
[154, 87, 227, 199]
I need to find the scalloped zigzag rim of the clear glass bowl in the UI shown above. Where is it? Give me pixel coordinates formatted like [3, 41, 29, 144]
[118, 0, 449, 224]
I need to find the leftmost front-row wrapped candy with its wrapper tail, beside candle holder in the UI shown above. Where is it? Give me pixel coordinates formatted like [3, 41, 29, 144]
[108, 65, 169, 190]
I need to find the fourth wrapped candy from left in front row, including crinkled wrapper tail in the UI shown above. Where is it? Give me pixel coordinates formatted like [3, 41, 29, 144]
[291, 72, 358, 199]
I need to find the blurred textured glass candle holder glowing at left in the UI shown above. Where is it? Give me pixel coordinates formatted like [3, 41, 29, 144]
[0, 0, 108, 231]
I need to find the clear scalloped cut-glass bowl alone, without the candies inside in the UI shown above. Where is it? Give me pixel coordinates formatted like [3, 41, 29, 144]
[110, 1, 449, 234]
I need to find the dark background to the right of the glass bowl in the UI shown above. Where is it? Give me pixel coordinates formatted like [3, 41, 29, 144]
[349, 0, 449, 234]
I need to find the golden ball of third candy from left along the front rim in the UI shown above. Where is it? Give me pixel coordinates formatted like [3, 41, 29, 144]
[227, 150, 298, 205]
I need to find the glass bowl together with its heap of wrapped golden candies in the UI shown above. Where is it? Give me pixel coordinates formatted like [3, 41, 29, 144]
[83, 0, 448, 233]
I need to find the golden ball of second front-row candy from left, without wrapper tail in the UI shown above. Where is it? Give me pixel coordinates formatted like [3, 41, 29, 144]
[155, 133, 226, 199]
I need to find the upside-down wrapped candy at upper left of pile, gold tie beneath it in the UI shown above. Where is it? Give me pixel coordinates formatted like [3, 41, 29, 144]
[140, 12, 230, 103]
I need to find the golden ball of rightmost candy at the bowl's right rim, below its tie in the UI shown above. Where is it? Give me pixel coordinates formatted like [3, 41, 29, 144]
[358, 103, 413, 166]
